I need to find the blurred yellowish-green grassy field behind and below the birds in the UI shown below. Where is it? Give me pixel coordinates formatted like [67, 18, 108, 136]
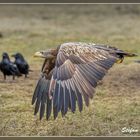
[0, 5, 140, 136]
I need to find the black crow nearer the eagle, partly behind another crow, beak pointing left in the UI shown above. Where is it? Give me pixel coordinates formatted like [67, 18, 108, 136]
[12, 53, 29, 78]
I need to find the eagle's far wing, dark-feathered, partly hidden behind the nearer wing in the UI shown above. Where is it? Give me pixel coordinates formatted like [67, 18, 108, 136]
[32, 59, 53, 120]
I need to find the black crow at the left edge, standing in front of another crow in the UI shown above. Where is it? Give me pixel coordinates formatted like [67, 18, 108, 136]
[0, 52, 21, 80]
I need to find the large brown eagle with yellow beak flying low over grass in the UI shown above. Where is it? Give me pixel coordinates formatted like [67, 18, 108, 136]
[32, 42, 136, 120]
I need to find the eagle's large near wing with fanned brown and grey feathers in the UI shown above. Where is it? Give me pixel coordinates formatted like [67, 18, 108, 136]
[49, 43, 117, 118]
